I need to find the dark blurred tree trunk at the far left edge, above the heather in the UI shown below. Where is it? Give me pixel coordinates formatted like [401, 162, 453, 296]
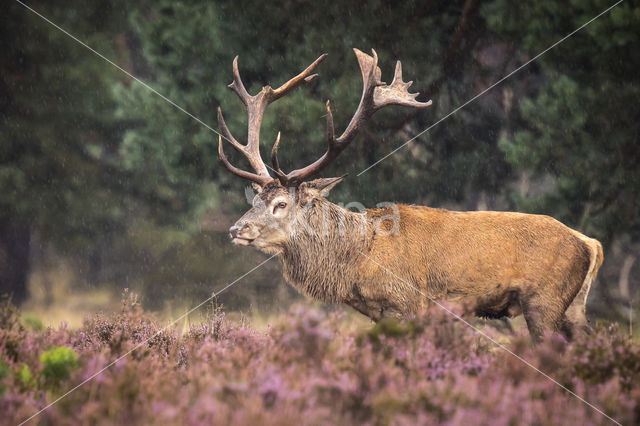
[0, 219, 31, 305]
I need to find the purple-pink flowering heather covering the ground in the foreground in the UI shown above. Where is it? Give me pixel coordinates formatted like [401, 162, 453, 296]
[0, 294, 640, 426]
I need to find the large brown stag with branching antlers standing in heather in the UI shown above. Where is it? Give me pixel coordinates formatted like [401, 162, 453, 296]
[217, 49, 603, 343]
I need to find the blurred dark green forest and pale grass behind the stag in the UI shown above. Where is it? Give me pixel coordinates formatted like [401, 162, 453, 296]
[0, 0, 640, 329]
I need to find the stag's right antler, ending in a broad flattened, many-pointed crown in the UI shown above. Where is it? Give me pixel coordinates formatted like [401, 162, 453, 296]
[271, 49, 431, 186]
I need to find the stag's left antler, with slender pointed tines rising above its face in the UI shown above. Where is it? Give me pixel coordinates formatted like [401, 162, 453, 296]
[218, 53, 327, 185]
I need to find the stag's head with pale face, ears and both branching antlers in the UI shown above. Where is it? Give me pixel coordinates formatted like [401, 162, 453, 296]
[218, 49, 431, 254]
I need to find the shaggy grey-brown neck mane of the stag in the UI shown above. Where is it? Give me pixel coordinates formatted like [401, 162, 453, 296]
[280, 198, 371, 302]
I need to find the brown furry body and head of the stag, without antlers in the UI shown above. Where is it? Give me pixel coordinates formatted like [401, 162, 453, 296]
[232, 180, 603, 340]
